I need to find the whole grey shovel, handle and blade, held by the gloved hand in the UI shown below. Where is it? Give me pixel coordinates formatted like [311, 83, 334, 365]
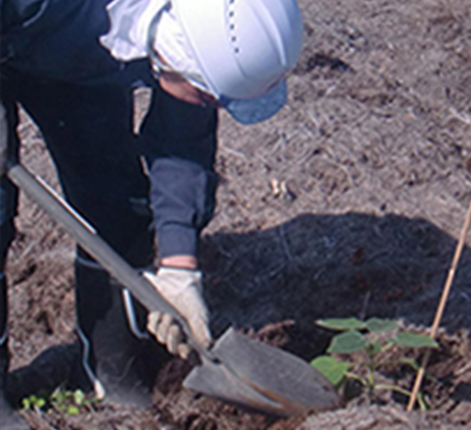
[8, 164, 341, 416]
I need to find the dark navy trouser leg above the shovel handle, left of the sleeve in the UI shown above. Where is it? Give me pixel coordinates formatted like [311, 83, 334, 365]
[4, 70, 152, 265]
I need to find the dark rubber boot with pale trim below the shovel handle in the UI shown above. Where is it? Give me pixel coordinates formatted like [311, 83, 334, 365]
[76, 258, 168, 407]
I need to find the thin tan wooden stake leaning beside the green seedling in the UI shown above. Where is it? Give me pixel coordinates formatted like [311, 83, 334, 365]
[407, 197, 471, 412]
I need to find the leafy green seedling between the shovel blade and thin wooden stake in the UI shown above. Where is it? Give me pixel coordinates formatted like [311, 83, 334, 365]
[311, 318, 438, 410]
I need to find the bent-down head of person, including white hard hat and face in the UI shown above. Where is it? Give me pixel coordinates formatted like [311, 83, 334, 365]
[149, 0, 303, 124]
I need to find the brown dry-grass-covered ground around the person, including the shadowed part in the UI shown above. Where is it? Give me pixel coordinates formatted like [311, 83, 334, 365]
[4, 0, 471, 430]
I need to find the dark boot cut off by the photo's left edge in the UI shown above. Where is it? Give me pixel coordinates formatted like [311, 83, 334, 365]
[0, 272, 31, 430]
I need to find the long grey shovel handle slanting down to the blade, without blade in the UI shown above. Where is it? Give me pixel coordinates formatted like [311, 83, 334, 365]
[7, 163, 209, 358]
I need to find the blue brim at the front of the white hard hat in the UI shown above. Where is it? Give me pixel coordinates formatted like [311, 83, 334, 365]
[218, 80, 288, 125]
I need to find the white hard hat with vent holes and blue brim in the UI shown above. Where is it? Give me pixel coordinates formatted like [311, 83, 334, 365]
[153, 0, 303, 124]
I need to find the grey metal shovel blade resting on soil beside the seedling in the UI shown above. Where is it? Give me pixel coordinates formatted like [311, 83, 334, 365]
[184, 328, 341, 416]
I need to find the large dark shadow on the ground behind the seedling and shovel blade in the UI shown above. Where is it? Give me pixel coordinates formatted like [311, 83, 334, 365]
[201, 213, 471, 358]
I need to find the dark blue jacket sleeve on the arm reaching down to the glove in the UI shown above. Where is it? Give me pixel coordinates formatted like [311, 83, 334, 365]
[141, 83, 217, 258]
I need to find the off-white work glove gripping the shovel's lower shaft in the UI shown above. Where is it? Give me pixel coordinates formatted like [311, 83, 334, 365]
[144, 267, 212, 359]
